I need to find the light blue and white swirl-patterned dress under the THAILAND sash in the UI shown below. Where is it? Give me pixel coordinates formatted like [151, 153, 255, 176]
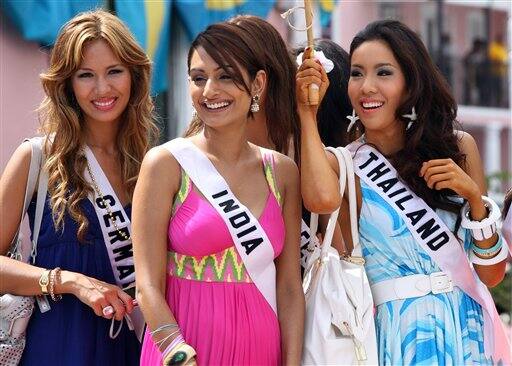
[359, 181, 492, 365]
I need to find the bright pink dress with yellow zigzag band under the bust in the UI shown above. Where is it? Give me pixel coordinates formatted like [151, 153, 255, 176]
[141, 153, 285, 366]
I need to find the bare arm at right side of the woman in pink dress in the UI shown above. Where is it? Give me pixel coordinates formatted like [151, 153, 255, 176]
[276, 155, 305, 365]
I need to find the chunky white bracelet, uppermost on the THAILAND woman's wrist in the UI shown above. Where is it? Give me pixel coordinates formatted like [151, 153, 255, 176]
[460, 196, 501, 240]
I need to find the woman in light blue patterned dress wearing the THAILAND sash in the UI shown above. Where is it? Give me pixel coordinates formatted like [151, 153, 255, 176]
[297, 20, 510, 365]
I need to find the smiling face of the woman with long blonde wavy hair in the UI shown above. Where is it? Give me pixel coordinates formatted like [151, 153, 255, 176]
[71, 40, 132, 123]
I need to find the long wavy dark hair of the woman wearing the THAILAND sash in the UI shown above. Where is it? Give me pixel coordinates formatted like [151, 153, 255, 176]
[350, 20, 465, 212]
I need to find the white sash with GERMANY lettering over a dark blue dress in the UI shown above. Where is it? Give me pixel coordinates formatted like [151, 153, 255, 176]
[84, 146, 144, 340]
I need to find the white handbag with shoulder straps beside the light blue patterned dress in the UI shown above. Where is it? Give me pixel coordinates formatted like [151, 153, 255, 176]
[302, 147, 378, 365]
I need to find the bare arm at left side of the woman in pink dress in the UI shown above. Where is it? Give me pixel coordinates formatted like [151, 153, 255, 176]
[132, 147, 181, 351]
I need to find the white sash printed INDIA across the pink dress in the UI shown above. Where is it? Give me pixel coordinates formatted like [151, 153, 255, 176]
[162, 138, 277, 314]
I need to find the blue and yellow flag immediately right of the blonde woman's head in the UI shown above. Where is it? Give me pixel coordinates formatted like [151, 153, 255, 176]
[115, 0, 172, 94]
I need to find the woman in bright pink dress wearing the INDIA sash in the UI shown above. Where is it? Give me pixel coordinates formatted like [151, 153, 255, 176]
[132, 23, 304, 365]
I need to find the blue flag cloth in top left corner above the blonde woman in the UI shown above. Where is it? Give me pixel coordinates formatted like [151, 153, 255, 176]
[0, 0, 105, 46]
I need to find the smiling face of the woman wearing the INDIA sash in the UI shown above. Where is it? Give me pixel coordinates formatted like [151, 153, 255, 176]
[189, 47, 251, 127]
